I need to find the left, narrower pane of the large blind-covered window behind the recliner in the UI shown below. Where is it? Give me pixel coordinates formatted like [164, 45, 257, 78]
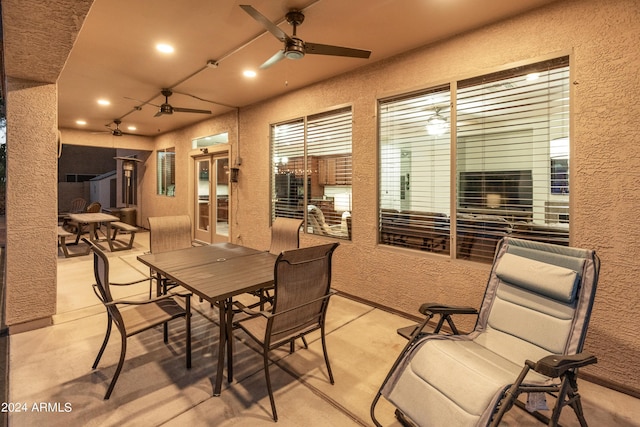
[378, 86, 451, 253]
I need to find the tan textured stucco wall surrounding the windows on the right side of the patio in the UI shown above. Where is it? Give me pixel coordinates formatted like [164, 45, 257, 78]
[139, 0, 640, 393]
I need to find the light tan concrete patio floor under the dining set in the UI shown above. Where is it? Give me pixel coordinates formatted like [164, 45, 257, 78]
[8, 233, 640, 427]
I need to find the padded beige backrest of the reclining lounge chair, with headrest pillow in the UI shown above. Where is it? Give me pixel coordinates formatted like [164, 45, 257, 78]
[474, 238, 600, 364]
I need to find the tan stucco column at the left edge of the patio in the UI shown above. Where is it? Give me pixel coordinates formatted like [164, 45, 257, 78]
[5, 78, 58, 333]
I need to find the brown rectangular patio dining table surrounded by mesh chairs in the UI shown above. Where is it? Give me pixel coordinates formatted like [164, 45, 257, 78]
[138, 243, 277, 396]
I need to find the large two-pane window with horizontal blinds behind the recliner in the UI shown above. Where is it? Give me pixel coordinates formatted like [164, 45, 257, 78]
[379, 57, 569, 263]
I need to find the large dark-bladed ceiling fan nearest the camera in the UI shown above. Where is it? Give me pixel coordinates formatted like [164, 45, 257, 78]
[240, 4, 371, 69]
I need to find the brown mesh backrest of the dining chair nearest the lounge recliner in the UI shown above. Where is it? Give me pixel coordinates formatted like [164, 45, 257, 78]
[267, 243, 339, 343]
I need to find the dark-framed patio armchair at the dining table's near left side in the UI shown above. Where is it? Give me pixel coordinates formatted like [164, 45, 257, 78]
[82, 238, 191, 400]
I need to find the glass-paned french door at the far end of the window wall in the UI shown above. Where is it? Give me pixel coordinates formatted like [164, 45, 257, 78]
[194, 152, 230, 243]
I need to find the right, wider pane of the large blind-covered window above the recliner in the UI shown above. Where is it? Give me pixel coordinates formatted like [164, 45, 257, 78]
[456, 57, 569, 263]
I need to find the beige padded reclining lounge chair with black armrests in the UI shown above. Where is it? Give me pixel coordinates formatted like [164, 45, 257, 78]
[371, 237, 600, 426]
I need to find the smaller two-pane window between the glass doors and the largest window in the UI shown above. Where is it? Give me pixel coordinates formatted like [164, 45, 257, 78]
[271, 107, 352, 239]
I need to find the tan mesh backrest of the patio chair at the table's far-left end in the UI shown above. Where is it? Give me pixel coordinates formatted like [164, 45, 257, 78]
[149, 215, 192, 254]
